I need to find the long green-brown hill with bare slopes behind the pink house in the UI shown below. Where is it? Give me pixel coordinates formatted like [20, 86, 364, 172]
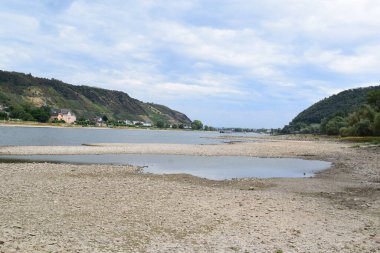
[0, 71, 191, 124]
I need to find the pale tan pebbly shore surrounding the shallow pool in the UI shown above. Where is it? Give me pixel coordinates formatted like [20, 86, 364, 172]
[0, 139, 380, 252]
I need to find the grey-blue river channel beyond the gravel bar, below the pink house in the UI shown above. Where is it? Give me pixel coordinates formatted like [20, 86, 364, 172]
[0, 126, 257, 146]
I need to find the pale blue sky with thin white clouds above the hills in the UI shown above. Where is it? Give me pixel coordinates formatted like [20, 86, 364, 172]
[0, 0, 380, 128]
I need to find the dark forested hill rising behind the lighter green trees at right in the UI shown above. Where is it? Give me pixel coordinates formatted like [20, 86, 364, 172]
[290, 86, 380, 125]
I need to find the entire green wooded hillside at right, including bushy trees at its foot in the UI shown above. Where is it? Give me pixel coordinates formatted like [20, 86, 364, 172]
[279, 86, 380, 136]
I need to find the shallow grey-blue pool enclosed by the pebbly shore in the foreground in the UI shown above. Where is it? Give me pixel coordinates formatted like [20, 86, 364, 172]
[0, 154, 331, 180]
